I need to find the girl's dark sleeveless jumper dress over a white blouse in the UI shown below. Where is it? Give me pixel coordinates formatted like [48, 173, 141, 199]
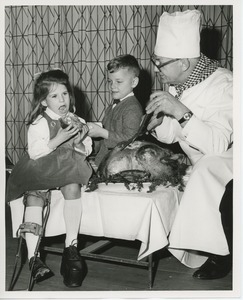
[6, 113, 92, 202]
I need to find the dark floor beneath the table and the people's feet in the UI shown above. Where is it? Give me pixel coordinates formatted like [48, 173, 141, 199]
[6, 202, 232, 297]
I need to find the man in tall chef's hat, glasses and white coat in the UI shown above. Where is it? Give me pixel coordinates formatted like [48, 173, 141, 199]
[146, 10, 233, 279]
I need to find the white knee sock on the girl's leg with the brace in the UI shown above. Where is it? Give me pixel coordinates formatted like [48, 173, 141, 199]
[24, 206, 43, 259]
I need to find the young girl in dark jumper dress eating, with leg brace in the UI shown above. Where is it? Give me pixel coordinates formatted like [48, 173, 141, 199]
[7, 70, 92, 287]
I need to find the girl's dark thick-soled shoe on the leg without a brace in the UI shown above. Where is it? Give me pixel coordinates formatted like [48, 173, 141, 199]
[60, 245, 87, 287]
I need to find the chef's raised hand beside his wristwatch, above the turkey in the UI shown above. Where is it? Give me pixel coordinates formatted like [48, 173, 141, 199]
[146, 91, 189, 126]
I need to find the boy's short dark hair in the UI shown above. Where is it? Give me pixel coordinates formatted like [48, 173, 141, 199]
[107, 54, 140, 77]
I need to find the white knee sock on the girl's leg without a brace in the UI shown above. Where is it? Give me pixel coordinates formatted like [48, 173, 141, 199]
[63, 198, 81, 247]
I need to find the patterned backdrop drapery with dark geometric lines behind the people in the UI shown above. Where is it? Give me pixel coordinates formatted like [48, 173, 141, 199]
[5, 5, 233, 163]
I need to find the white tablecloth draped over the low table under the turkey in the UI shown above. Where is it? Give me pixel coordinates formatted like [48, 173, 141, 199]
[10, 183, 179, 260]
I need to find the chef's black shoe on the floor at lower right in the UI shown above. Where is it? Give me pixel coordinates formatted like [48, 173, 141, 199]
[193, 255, 232, 279]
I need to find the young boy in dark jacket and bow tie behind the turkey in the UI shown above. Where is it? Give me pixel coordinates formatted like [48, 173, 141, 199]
[87, 54, 143, 167]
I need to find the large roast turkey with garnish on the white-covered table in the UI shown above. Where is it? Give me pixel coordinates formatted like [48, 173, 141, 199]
[89, 141, 188, 190]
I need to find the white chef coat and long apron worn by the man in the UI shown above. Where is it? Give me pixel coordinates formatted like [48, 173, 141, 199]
[155, 68, 233, 267]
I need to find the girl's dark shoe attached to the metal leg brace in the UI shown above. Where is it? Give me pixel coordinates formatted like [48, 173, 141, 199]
[29, 256, 54, 281]
